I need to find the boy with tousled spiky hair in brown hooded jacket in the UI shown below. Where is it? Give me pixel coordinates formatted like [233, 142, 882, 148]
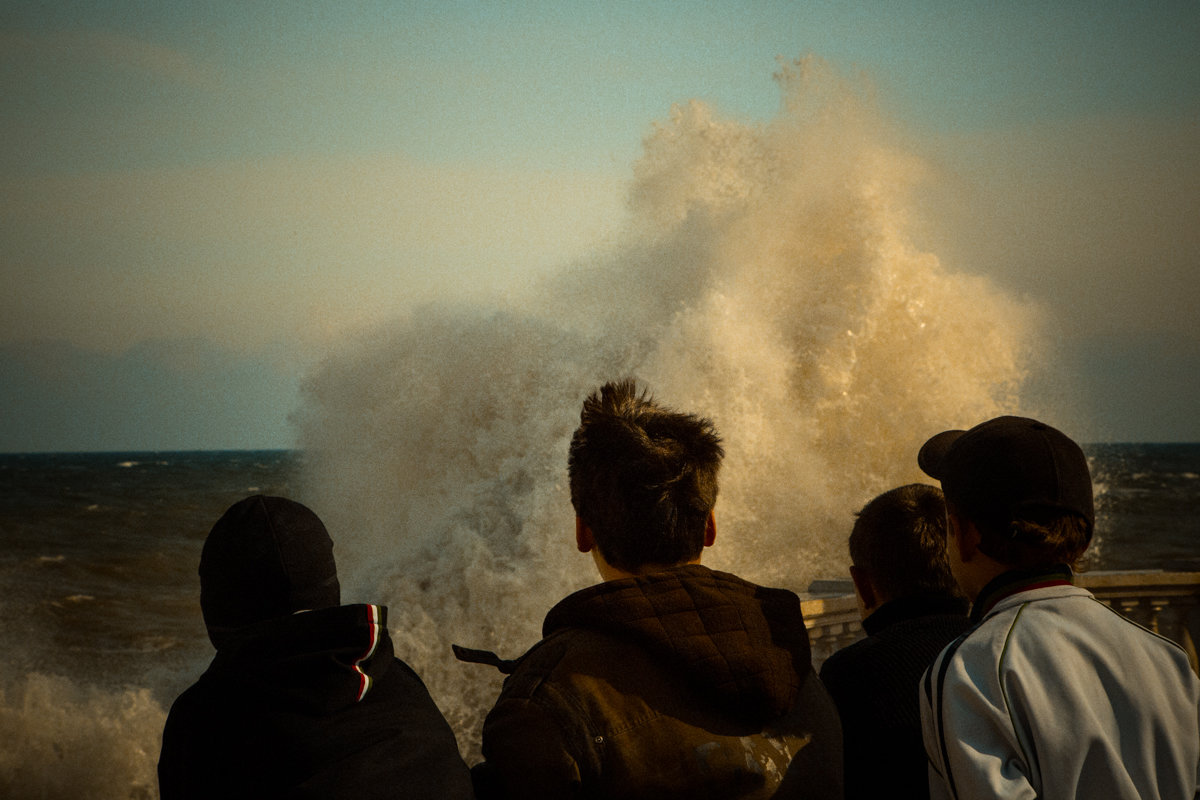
[458, 380, 842, 800]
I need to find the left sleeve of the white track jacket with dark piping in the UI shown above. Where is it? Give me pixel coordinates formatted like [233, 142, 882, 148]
[920, 645, 1038, 800]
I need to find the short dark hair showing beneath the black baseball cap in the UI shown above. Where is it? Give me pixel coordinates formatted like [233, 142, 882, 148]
[946, 498, 1092, 570]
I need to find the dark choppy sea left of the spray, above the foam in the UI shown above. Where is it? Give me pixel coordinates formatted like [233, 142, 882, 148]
[0, 451, 296, 685]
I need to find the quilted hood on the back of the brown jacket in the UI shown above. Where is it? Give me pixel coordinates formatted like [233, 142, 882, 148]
[542, 565, 812, 721]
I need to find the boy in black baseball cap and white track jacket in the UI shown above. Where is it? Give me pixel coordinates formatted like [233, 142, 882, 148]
[918, 416, 1200, 800]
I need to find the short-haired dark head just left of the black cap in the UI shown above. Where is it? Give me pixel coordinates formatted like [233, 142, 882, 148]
[850, 483, 959, 600]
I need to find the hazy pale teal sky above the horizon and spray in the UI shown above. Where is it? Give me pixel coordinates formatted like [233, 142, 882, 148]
[0, 1, 1200, 450]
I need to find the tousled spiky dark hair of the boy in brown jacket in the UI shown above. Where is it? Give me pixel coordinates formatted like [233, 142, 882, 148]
[566, 379, 725, 572]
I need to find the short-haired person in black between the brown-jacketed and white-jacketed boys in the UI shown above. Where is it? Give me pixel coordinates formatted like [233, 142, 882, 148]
[821, 483, 968, 800]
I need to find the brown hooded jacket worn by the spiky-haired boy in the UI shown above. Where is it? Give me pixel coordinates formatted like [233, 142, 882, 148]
[474, 565, 841, 799]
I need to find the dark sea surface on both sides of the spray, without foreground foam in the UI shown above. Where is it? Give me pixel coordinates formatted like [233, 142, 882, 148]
[0, 444, 1200, 691]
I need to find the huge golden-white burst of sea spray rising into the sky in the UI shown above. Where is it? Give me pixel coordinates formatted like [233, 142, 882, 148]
[295, 59, 1037, 757]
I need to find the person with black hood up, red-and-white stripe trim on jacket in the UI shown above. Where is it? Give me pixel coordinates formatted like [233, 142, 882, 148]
[158, 495, 472, 800]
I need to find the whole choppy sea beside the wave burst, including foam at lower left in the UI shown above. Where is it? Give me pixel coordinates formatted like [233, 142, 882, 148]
[0, 444, 1200, 798]
